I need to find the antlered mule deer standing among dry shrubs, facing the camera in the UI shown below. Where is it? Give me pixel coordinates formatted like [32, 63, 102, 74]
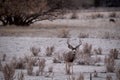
[64, 39, 82, 73]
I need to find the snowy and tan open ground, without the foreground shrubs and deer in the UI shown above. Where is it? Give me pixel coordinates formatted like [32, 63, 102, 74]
[0, 10, 120, 80]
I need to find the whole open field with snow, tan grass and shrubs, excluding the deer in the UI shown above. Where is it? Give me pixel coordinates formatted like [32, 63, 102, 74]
[0, 12, 120, 80]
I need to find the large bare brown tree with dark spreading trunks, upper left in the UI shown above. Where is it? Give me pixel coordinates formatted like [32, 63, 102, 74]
[0, 0, 56, 26]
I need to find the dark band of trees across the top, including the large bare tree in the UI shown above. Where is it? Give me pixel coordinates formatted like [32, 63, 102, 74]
[0, 0, 120, 26]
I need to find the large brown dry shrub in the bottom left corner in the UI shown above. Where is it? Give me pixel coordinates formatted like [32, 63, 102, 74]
[2, 64, 15, 80]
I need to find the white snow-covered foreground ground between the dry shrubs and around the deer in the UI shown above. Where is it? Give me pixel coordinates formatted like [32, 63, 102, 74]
[0, 37, 120, 80]
